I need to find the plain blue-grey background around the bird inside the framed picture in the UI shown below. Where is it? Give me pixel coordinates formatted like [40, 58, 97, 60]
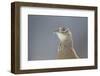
[28, 15, 88, 60]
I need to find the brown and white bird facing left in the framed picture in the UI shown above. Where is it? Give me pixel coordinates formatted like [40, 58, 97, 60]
[55, 26, 79, 59]
